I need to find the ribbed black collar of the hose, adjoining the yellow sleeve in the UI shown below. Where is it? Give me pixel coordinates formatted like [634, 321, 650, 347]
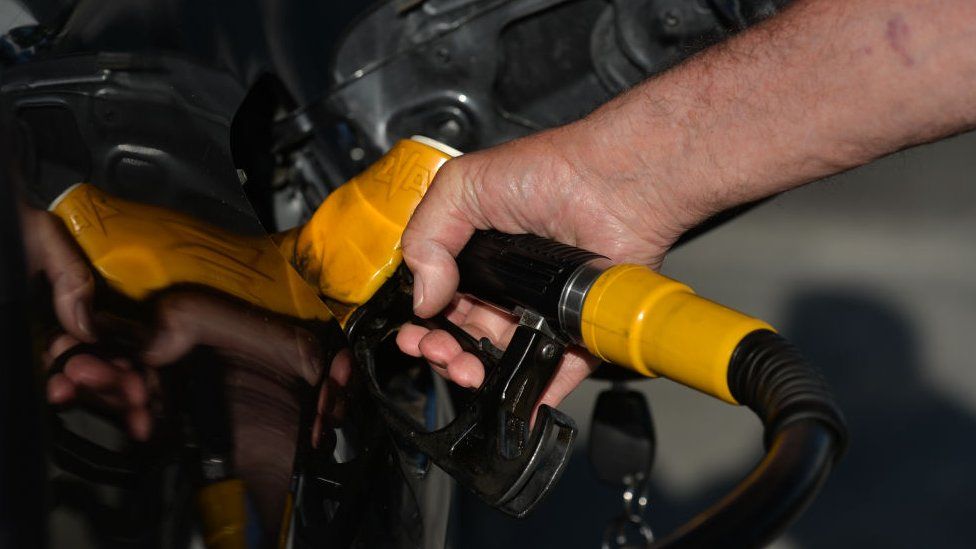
[728, 330, 847, 457]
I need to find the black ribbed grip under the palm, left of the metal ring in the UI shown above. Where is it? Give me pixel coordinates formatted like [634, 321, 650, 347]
[457, 231, 602, 327]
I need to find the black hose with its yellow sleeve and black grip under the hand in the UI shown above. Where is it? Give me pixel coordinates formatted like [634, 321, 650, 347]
[458, 231, 847, 547]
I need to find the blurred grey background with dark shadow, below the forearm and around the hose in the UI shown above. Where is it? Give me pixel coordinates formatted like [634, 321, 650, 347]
[0, 1, 976, 548]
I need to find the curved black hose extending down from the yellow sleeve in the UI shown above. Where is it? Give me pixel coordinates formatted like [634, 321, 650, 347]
[651, 330, 847, 548]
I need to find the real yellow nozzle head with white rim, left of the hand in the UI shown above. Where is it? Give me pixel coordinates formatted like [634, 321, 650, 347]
[288, 137, 460, 326]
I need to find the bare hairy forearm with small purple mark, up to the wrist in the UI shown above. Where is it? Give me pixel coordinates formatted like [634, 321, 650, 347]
[564, 0, 976, 224]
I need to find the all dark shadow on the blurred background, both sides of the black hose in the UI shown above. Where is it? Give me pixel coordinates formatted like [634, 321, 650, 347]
[455, 288, 976, 549]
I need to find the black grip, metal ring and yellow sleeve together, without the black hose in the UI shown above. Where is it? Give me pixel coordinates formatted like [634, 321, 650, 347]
[458, 231, 773, 403]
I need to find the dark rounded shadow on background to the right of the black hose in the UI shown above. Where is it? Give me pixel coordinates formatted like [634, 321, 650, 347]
[784, 290, 976, 548]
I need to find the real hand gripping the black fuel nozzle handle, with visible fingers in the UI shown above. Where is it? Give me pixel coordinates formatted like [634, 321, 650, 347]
[397, 121, 710, 406]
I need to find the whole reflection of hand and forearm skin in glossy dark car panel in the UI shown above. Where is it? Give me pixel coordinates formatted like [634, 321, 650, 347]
[20, 207, 352, 534]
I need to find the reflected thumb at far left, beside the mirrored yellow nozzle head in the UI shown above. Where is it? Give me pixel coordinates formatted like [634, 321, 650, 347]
[22, 208, 95, 343]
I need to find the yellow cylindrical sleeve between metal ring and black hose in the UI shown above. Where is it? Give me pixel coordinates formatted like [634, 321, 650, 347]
[580, 265, 773, 404]
